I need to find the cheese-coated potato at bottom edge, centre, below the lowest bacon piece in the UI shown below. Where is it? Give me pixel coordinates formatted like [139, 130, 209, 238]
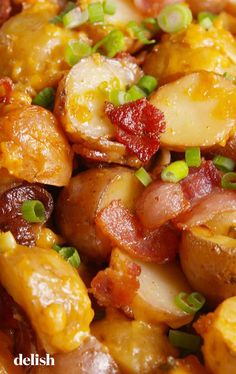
[91, 312, 177, 374]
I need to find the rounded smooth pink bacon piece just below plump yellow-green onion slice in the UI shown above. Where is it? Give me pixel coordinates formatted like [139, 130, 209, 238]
[136, 181, 190, 229]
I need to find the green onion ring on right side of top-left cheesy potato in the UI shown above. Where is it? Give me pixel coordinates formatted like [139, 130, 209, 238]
[65, 40, 92, 66]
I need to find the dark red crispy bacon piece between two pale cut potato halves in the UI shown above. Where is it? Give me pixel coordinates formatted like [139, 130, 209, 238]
[105, 98, 165, 162]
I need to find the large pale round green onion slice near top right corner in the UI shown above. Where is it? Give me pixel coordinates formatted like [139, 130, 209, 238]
[157, 4, 193, 33]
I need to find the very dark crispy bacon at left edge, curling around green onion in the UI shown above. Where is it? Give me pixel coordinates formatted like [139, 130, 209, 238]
[0, 184, 53, 246]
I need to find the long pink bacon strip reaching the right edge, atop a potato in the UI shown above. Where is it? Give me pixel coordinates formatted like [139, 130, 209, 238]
[175, 189, 236, 230]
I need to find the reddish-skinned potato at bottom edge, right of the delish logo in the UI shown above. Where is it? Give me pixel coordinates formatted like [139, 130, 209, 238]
[30, 336, 120, 374]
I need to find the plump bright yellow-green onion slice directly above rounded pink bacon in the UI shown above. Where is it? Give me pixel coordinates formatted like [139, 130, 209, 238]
[161, 161, 189, 183]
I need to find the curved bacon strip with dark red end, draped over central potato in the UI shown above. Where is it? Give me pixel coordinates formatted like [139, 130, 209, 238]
[96, 201, 178, 264]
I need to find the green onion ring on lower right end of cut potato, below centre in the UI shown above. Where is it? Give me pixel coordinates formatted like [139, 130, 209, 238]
[175, 292, 206, 314]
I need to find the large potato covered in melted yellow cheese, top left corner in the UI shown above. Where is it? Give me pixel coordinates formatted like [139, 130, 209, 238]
[0, 1, 82, 95]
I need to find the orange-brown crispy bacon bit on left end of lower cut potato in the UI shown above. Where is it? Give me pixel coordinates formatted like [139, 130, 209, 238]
[91, 262, 141, 308]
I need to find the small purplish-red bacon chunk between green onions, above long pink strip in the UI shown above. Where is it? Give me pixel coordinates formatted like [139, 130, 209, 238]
[180, 161, 221, 205]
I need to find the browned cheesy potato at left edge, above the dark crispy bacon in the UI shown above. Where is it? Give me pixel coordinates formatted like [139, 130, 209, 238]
[0, 105, 72, 186]
